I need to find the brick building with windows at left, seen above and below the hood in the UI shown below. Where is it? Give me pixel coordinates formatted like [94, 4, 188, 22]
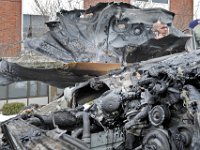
[0, 0, 57, 109]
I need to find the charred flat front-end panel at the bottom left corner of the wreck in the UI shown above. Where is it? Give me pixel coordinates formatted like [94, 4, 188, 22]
[2, 118, 89, 150]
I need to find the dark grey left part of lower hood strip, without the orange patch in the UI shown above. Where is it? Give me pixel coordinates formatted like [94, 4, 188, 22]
[0, 60, 94, 88]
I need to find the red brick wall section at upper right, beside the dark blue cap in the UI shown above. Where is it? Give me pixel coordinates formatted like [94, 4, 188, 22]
[170, 0, 193, 30]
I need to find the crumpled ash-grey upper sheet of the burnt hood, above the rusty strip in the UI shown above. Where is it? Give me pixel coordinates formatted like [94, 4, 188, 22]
[28, 3, 188, 63]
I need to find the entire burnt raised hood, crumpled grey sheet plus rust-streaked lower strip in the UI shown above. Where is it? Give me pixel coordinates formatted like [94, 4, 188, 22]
[0, 3, 188, 88]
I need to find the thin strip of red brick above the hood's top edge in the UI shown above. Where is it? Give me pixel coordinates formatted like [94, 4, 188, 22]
[84, 0, 130, 9]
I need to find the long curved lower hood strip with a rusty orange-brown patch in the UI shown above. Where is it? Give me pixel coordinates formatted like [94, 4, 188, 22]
[0, 60, 120, 88]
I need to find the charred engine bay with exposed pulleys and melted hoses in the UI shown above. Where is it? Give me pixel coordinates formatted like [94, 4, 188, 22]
[2, 50, 200, 150]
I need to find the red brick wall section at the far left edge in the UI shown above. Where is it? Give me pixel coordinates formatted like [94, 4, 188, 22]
[0, 0, 22, 57]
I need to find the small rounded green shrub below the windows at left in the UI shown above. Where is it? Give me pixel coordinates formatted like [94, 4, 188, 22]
[2, 102, 25, 115]
